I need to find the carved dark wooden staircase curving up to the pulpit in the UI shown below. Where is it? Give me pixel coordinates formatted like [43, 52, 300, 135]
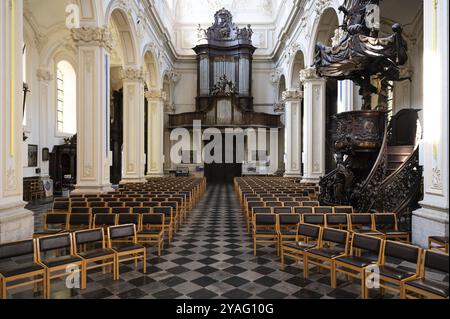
[320, 109, 423, 217]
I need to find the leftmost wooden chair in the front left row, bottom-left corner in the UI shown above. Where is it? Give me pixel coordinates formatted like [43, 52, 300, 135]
[0, 239, 47, 299]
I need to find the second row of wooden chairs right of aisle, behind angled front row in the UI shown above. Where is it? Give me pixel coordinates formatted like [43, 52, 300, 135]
[252, 214, 410, 256]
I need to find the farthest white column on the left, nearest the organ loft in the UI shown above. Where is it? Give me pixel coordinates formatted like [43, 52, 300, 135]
[145, 90, 164, 178]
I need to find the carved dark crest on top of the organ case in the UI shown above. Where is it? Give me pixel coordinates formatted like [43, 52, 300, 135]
[198, 8, 253, 45]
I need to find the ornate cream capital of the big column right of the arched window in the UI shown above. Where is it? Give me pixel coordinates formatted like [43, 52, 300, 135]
[70, 26, 114, 51]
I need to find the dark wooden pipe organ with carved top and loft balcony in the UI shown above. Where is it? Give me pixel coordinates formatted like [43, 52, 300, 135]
[169, 9, 282, 128]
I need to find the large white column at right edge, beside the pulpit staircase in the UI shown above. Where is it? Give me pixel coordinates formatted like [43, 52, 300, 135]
[412, 0, 449, 247]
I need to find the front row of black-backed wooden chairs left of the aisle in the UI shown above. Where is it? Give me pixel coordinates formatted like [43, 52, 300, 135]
[0, 224, 148, 299]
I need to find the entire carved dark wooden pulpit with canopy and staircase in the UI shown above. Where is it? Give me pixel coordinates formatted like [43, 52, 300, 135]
[315, 0, 423, 215]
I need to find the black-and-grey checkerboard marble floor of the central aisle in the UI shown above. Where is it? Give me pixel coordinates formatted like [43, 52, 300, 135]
[6, 185, 448, 299]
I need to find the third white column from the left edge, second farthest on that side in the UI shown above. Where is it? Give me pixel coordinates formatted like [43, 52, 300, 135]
[121, 69, 145, 183]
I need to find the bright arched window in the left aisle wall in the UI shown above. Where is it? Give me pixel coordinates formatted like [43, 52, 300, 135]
[56, 60, 77, 135]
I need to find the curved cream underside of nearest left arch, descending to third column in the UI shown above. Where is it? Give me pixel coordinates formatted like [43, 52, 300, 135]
[105, 1, 141, 68]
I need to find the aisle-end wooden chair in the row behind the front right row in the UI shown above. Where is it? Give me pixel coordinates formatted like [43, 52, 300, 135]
[253, 214, 280, 256]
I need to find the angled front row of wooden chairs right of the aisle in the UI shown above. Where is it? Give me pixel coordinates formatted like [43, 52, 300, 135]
[280, 223, 449, 299]
